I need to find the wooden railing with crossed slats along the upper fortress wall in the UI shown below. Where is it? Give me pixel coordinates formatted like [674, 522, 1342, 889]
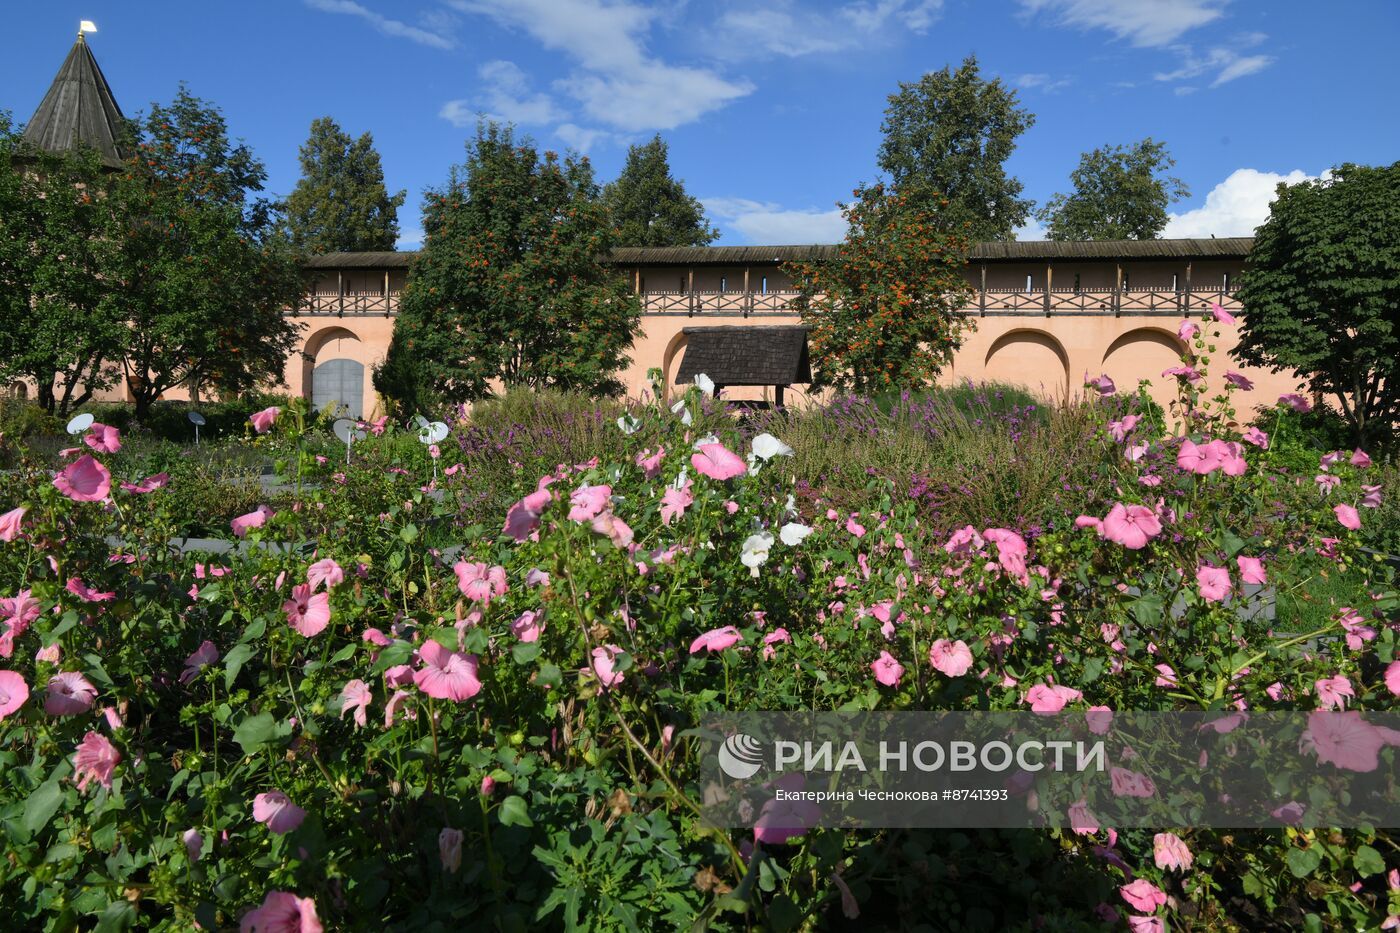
[289, 287, 1240, 317]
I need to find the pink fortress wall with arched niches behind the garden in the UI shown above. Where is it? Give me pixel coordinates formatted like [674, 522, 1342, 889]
[68, 243, 1299, 416]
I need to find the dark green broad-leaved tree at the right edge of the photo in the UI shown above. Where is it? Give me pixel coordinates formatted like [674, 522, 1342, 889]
[1236, 163, 1400, 447]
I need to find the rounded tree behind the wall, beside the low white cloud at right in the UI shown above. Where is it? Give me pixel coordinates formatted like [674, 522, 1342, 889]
[1036, 137, 1191, 240]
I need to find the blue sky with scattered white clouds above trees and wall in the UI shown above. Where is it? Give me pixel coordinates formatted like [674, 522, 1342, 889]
[0, 0, 1400, 247]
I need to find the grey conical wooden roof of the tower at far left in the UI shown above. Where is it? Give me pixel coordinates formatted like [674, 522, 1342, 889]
[24, 34, 126, 168]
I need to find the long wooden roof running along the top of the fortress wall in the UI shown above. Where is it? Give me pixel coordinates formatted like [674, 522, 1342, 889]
[305, 237, 1254, 269]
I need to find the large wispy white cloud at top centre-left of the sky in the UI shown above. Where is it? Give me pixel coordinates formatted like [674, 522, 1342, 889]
[449, 0, 753, 132]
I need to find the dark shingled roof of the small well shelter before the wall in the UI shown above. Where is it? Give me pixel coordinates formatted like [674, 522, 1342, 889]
[676, 326, 812, 385]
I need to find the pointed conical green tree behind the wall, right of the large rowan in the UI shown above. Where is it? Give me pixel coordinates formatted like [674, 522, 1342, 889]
[603, 133, 720, 247]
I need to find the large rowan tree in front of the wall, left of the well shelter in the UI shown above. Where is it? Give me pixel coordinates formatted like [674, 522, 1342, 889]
[375, 123, 641, 410]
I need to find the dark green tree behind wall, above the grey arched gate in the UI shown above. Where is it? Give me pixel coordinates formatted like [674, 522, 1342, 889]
[287, 116, 405, 254]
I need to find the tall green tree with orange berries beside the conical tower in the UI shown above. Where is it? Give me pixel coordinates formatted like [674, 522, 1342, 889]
[111, 85, 304, 416]
